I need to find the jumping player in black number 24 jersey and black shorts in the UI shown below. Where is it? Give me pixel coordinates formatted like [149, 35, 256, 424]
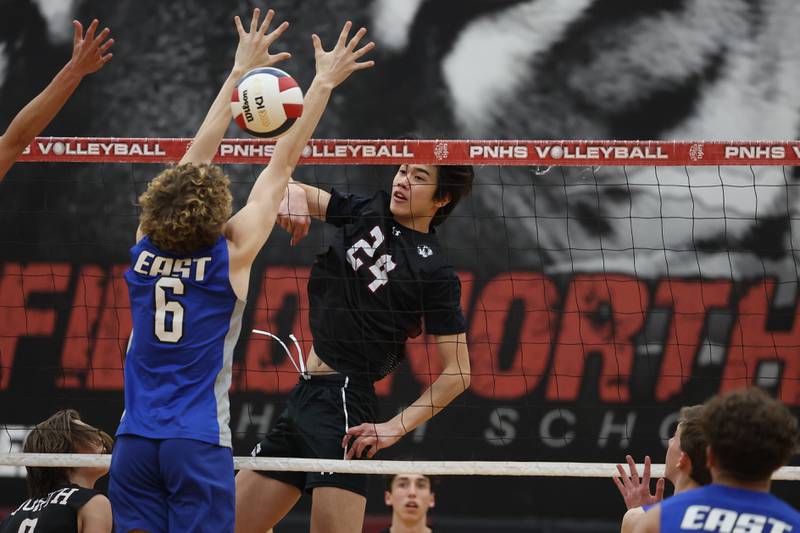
[236, 164, 474, 533]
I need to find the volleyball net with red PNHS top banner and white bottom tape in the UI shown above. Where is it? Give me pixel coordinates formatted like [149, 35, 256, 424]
[0, 138, 800, 486]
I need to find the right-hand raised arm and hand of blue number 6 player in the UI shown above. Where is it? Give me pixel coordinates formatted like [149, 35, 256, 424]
[225, 22, 375, 266]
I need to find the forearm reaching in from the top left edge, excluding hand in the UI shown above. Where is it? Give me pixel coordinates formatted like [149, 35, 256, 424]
[3, 63, 83, 153]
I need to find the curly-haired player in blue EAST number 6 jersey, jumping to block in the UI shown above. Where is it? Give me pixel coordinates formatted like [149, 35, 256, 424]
[109, 9, 373, 533]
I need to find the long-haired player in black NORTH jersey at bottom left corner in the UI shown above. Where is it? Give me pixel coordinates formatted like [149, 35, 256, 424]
[0, 409, 113, 533]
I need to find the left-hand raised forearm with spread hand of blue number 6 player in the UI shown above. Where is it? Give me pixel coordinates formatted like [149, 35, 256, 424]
[179, 8, 291, 165]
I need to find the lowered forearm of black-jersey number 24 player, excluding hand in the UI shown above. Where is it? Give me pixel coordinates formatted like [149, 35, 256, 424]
[391, 364, 470, 435]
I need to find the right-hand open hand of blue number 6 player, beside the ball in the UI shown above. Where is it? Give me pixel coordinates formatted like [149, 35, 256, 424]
[311, 21, 375, 87]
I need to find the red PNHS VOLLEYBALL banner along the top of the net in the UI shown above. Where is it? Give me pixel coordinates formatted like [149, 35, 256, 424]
[20, 137, 800, 166]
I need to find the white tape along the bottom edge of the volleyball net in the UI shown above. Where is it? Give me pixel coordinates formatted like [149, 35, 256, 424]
[0, 453, 800, 481]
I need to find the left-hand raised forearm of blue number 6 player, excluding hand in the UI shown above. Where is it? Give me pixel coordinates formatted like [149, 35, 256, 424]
[179, 68, 244, 165]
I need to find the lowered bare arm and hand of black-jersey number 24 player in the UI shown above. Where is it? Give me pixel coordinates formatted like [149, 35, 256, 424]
[342, 333, 470, 459]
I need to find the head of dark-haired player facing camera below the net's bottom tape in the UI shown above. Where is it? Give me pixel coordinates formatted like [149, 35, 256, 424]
[381, 474, 436, 533]
